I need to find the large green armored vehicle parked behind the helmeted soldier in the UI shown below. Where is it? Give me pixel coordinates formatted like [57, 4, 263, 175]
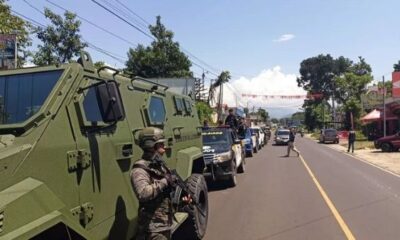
[0, 53, 208, 240]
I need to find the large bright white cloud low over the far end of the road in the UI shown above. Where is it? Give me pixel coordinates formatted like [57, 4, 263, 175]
[216, 66, 306, 117]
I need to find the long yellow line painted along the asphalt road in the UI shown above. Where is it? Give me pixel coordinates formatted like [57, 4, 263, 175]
[300, 155, 355, 240]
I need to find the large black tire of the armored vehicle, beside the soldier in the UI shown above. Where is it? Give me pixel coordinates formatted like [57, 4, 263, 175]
[180, 173, 208, 239]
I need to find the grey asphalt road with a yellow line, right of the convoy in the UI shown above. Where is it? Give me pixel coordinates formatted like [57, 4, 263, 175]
[205, 137, 400, 240]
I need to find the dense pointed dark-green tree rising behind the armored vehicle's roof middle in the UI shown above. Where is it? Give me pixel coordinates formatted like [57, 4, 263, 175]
[125, 16, 193, 78]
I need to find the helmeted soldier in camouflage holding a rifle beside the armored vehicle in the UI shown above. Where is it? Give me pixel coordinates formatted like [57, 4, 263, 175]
[131, 127, 173, 240]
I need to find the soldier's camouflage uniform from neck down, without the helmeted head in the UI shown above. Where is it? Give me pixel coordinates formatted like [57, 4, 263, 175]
[131, 152, 173, 240]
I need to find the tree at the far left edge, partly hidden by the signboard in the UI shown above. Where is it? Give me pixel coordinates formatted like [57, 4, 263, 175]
[0, 0, 32, 68]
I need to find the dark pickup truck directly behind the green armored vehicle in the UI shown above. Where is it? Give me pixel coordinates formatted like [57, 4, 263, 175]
[202, 127, 246, 187]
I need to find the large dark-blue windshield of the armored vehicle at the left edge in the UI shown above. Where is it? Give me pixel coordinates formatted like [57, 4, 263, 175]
[0, 70, 62, 124]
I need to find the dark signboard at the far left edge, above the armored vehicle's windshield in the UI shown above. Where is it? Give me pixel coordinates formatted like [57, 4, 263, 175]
[0, 34, 17, 70]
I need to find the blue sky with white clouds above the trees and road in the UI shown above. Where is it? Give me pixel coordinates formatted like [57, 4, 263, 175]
[8, 0, 400, 117]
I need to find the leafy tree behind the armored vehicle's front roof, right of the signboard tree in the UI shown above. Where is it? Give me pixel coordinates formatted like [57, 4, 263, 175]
[33, 8, 87, 66]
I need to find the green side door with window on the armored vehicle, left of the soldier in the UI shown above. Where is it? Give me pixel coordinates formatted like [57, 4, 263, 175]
[68, 76, 137, 239]
